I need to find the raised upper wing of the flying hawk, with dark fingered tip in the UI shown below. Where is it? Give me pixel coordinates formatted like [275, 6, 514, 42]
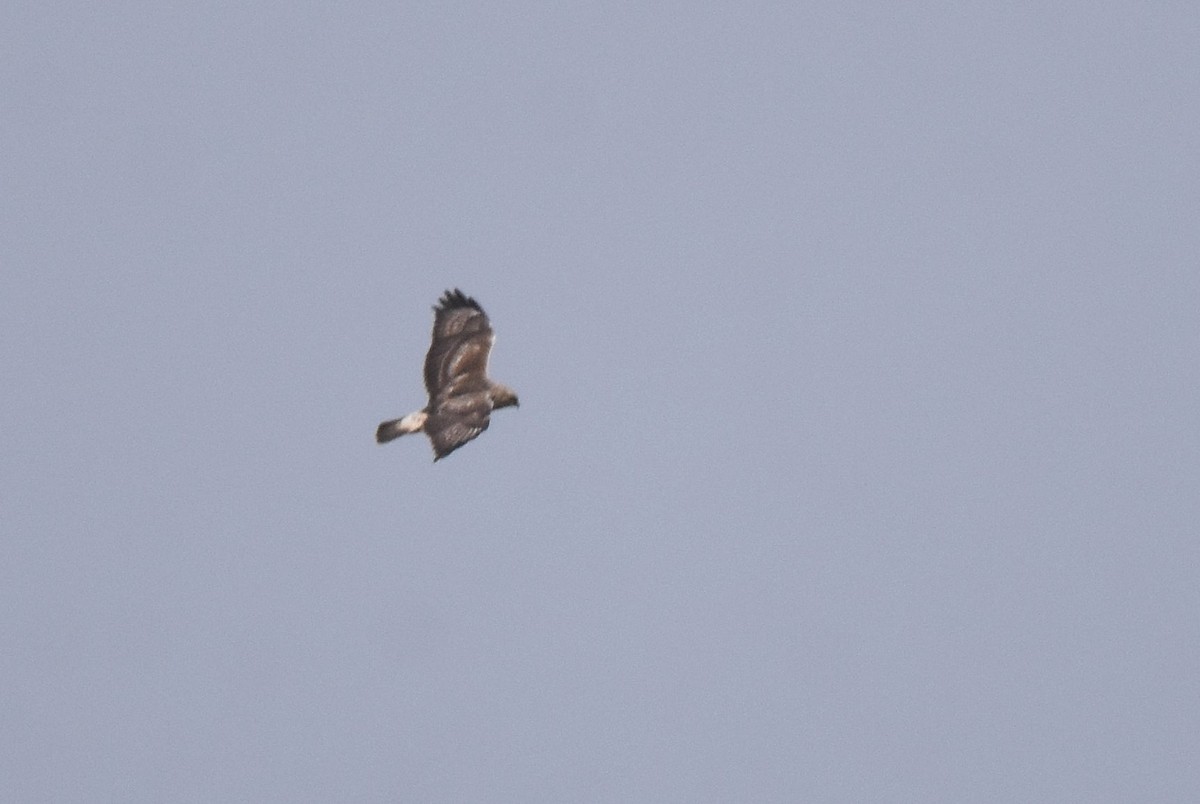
[425, 288, 496, 403]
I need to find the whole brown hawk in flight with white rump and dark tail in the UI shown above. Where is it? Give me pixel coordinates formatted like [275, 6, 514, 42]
[376, 288, 518, 461]
